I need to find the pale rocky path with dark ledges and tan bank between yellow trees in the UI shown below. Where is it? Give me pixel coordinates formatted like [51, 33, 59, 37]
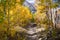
[14, 24, 46, 40]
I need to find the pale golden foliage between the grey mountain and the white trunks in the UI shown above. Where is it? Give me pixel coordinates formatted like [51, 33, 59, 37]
[34, 6, 48, 30]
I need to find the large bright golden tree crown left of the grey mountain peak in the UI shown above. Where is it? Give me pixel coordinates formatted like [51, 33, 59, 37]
[9, 4, 32, 26]
